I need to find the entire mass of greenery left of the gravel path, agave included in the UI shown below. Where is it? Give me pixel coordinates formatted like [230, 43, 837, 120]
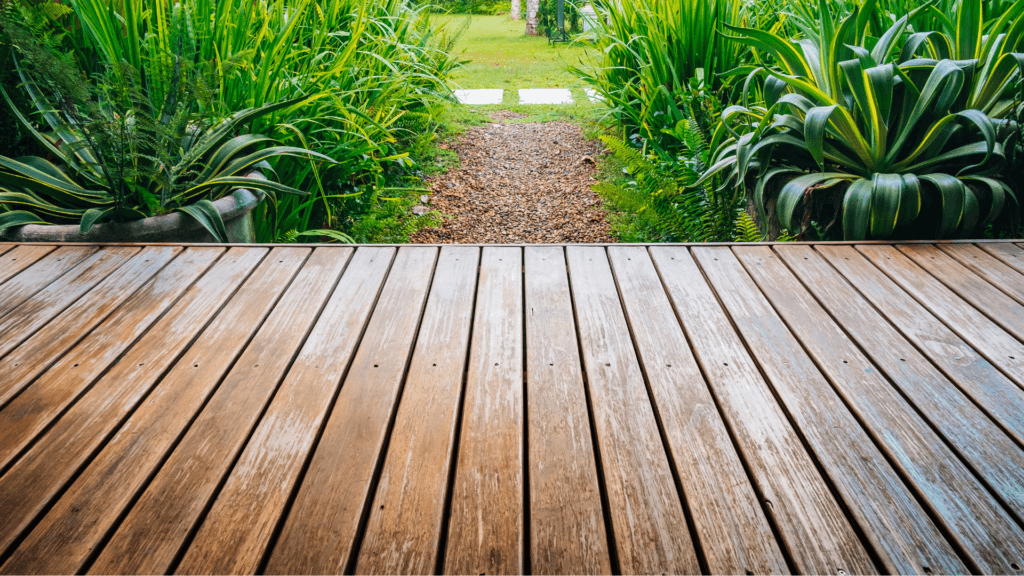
[0, 0, 459, 241]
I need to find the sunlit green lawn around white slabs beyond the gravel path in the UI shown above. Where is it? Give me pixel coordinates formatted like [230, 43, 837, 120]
[437, 14, 604, 122]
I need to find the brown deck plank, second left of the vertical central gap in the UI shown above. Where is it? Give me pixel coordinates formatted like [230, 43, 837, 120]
[355, 246, 479, 574]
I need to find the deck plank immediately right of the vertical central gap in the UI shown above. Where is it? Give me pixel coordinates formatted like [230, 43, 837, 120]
[523, 247, 611, 574]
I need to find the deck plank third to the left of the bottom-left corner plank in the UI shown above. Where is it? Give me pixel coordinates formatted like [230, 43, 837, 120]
[0, 246, 181, 407]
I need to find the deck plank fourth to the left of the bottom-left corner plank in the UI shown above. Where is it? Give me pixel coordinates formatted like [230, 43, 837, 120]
[0, 243, 139, 354]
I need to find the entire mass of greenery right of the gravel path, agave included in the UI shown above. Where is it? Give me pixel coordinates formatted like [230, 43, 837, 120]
[572, 0, 1024, 241]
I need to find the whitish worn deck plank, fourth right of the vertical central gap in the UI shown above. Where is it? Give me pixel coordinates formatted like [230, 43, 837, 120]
[649, 246, 876, 574]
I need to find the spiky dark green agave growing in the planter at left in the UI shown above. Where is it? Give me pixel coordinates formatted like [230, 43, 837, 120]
[0, 11, 332, 242]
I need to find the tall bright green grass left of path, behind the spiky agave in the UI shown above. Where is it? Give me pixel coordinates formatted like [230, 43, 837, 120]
[0, 0, 458, 241]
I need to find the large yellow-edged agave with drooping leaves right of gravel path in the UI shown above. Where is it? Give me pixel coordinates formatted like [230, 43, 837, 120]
[698, 0, 1021, 240]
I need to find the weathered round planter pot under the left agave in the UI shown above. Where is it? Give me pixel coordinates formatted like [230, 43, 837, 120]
[0, 172, 264, 243]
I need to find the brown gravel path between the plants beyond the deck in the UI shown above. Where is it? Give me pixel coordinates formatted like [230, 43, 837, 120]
[412, 112, 614, 244]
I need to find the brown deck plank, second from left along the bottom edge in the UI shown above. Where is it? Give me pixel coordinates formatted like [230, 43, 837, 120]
[82, 243, 351, 573]
